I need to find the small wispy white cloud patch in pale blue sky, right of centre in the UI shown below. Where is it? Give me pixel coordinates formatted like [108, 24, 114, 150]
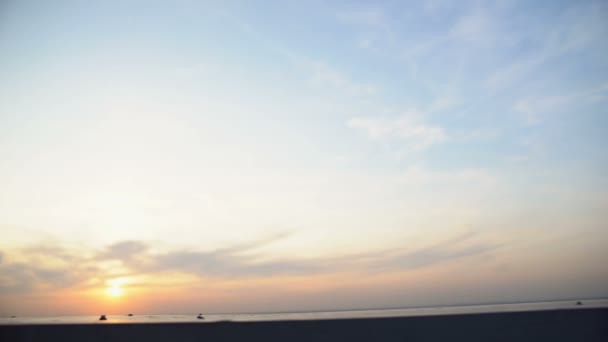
[346, 116, 447, 151]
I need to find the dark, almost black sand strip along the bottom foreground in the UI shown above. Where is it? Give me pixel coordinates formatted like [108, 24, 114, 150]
[0, 308, 608, 342]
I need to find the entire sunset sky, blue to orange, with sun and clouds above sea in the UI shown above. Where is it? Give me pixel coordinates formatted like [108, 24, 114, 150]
[0, 0, 608, 316]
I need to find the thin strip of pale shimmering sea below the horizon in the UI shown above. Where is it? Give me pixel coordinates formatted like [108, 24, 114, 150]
[0, 299, 608, 325]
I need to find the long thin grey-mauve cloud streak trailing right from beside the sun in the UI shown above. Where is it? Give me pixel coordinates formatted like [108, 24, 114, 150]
[132, 232, 500, 279]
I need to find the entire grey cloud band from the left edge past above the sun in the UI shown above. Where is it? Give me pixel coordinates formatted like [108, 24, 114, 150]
[0, 233, 498, 295]
